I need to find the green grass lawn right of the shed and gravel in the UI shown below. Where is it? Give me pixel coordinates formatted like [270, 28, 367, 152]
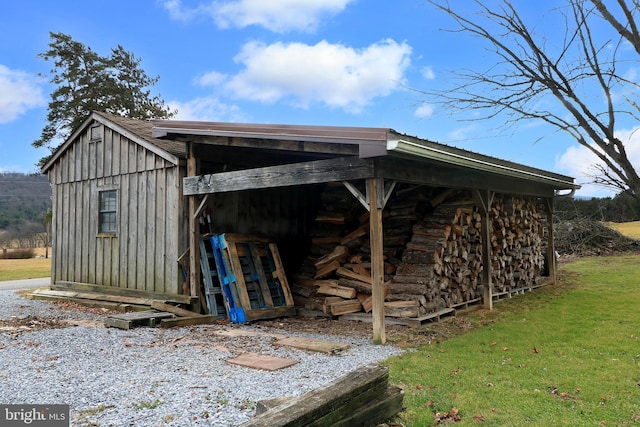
[387, 255, 640, 426]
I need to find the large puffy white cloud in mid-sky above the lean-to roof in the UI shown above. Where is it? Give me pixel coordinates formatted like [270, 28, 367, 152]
[225, 40, 411, 112]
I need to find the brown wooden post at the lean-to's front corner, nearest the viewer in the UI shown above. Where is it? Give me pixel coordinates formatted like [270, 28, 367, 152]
[367, 178, 387, 344]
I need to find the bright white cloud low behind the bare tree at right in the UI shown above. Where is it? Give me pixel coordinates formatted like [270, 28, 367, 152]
[555, 127, 640, 197]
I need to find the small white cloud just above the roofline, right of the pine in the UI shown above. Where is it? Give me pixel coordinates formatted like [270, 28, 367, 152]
[168, 96, 248, 122]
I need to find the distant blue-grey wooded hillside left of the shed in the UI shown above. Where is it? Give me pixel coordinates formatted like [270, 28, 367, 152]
[0, 172, 51, 230]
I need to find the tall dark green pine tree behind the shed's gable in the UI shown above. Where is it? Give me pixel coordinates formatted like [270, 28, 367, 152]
[32, 33, 176, 165]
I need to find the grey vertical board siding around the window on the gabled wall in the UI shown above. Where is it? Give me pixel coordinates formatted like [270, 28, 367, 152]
[49, 122, 182, 294]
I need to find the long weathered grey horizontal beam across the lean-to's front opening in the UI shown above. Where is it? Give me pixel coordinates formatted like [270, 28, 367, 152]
[183, 157, 374, 196]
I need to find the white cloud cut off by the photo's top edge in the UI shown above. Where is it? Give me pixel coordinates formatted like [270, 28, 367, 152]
[164, 0, 353, 33]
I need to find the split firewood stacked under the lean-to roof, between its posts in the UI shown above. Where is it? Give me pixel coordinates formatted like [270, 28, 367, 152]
[292, 186, 546, 318]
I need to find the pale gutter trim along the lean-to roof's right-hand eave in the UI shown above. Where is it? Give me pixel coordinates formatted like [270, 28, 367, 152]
[387, 139, 580, 190]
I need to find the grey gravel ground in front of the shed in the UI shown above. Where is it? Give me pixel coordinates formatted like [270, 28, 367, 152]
[0, 290, 401, 427]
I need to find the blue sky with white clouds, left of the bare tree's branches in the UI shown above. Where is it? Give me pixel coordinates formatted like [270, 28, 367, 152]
[0, 0, 640, 196]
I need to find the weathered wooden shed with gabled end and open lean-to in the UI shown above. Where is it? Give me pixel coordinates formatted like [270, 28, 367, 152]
[44, 113, 578, 342]
